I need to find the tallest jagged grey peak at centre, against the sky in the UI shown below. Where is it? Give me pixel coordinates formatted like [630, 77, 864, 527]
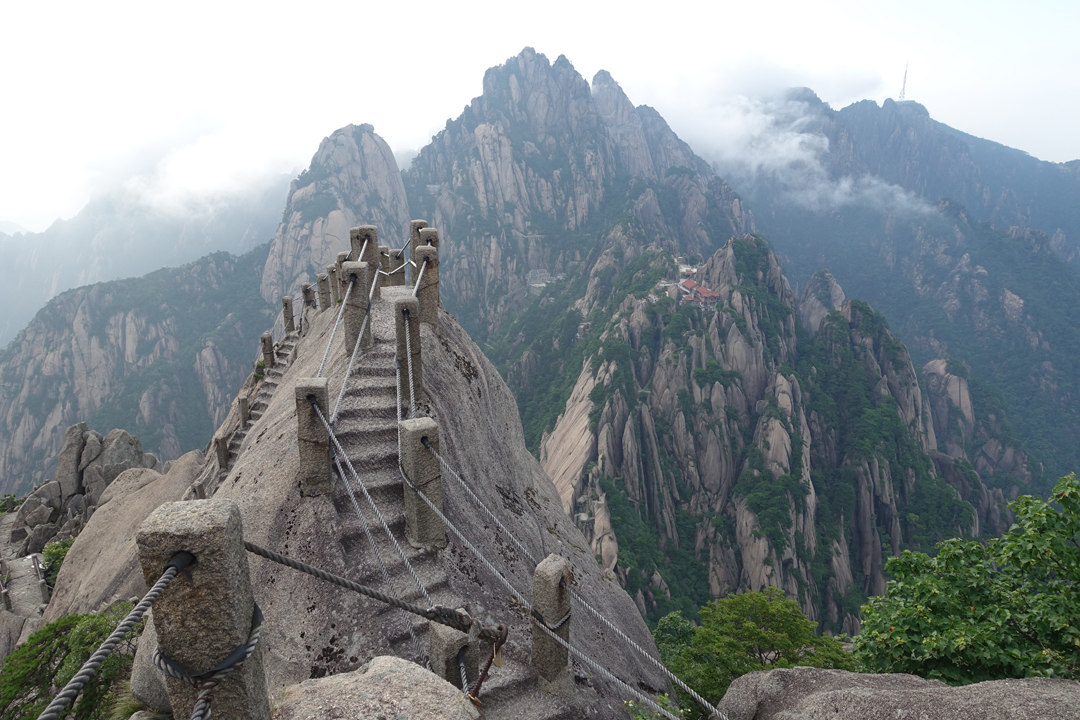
[405, 47, 753, 337]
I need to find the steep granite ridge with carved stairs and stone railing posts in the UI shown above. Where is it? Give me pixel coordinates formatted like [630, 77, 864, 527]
[23, 221, 671, 720]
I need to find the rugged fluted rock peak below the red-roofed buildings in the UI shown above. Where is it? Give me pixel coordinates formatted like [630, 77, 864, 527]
[535, 236, 1004, 633]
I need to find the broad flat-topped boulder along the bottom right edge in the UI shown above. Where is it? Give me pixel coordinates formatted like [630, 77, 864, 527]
[719, 667, 1080, 720]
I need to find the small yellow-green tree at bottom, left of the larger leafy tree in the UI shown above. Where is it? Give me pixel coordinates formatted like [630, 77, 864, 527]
[652, 587, 854, 718]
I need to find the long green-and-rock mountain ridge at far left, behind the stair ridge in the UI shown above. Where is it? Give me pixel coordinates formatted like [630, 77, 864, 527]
[0, 245, 273, 492]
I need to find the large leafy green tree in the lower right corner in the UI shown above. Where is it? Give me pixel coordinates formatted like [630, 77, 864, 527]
[855, 475, 1080, 684]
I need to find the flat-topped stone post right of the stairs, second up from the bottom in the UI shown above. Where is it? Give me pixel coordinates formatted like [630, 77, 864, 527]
[397, 418, 446, 547]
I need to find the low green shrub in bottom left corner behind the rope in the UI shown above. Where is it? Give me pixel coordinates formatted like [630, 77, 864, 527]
[0, 602, 141, 720]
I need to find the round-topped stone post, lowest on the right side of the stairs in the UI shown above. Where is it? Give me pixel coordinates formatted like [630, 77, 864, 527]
[532, 555, 573, 697]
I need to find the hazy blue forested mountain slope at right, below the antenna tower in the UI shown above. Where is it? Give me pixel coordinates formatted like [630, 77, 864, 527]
[744, 92, 1080, 488]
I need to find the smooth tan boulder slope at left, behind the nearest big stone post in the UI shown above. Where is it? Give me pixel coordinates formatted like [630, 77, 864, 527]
[44, 451, 203, 623]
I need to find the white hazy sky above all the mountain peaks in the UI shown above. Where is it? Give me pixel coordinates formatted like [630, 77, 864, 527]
[0, 0, 1080, 231]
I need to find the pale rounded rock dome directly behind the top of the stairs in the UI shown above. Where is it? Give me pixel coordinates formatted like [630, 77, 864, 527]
[261, 124, 409, 302]
